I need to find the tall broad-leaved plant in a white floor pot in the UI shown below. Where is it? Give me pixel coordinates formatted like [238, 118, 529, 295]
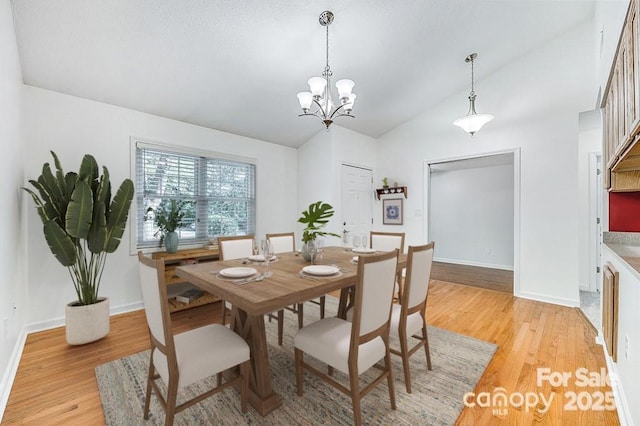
[23, 151, 134, 345]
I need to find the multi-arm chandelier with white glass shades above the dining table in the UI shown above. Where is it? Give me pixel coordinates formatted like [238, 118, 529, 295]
[298, 10, 356, 130]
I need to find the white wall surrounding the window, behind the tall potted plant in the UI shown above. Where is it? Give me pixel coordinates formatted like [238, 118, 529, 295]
[24, 86, 298, 326]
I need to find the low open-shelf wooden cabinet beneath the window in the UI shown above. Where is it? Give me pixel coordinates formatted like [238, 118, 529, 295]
[151, 249, 220, 312]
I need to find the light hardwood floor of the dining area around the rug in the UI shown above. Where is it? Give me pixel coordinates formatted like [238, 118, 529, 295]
[2, 280, 619, 425]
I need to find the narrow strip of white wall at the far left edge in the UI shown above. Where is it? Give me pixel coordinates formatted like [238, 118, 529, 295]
[0, 0, 28, 418]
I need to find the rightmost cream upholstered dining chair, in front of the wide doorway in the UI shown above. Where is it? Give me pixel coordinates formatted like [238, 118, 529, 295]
[384, 241, 435, 393]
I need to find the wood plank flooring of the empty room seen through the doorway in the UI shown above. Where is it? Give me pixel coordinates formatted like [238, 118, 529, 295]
[431, 261, 513, 294]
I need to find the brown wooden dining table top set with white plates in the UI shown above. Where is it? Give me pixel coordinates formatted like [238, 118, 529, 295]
[176, 247, 407, 315]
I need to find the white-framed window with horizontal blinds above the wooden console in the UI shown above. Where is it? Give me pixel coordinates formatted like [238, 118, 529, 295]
[136, 142, 256, 247]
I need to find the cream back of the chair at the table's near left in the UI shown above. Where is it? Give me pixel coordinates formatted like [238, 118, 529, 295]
[138, 252, 171, 346]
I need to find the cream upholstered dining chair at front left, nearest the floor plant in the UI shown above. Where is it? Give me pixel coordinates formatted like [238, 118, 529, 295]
[138, 252, 251, 425]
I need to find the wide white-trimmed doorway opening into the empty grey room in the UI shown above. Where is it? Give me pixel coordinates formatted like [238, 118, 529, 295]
[425, 150, 520, 294]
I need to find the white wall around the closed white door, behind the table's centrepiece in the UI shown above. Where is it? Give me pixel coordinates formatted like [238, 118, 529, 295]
[298, 124, 377, 244]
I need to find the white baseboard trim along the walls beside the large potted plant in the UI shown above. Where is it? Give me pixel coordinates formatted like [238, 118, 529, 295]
[0, 301, 144, 423]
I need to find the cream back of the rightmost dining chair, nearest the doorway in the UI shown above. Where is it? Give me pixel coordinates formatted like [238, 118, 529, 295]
[404, 241, 435, 308]
